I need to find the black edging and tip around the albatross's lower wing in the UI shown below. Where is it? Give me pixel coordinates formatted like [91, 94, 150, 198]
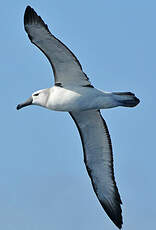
[69, 110, 123, 229]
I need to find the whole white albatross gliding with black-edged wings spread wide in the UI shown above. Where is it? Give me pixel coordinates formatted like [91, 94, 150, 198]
[17, 6, 139, 229]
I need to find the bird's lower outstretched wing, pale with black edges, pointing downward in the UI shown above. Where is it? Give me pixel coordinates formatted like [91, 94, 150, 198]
[70, 111, 122, 228]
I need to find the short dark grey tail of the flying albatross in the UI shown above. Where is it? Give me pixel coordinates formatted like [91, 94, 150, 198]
[113, 92, 140, 107]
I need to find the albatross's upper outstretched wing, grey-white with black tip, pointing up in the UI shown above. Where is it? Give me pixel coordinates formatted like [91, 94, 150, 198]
[24, 6, 90, 86]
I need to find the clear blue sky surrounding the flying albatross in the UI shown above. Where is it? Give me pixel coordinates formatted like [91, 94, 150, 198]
[0, 0, 156, 230]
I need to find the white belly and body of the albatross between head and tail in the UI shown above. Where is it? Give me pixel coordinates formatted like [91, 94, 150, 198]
[46, 86, 116, 112]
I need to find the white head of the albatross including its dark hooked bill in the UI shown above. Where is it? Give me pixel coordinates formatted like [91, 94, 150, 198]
[16, 89, 49, 110]
